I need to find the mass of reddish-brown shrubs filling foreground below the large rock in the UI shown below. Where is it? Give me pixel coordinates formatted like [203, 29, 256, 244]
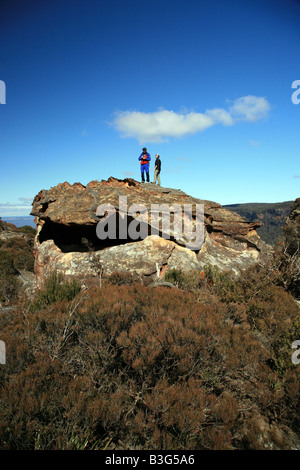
[0, 275, 299, 450]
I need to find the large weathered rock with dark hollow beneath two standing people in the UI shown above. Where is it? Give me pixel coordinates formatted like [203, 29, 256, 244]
[31, 178, 264, 284]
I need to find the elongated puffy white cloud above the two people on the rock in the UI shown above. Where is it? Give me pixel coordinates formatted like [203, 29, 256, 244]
[113, 96, 270, 143]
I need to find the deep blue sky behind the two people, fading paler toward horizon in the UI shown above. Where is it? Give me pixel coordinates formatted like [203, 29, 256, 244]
[0, 0, 300, 217]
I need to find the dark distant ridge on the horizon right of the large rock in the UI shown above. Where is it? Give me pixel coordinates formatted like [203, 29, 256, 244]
[223, 201, 294, 245]
